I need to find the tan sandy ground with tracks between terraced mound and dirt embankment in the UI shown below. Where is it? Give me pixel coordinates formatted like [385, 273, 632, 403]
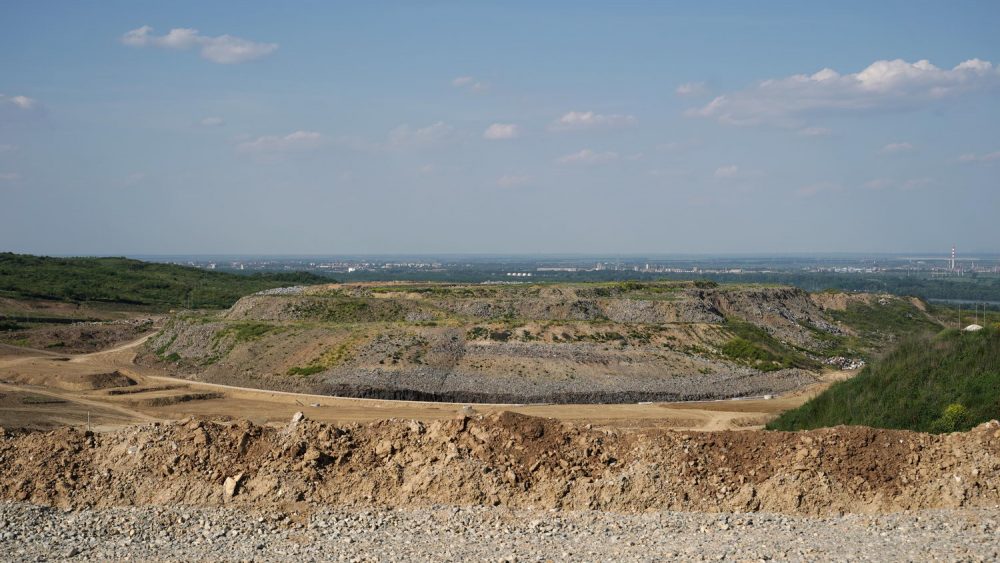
[0, 336, 854, 431]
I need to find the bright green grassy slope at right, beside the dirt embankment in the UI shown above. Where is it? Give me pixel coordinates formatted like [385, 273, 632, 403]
[768, 328, 1000, 432]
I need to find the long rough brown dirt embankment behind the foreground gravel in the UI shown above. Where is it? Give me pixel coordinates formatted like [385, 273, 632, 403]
[0, 413, 1000, 515]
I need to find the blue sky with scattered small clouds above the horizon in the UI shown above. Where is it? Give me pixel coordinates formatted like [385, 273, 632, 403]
[0, 0, 1000, 255]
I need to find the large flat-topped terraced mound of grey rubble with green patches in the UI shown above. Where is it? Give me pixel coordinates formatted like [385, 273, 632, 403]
[143, 282, 936, 403]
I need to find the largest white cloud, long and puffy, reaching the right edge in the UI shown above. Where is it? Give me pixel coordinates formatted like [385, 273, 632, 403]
[687, 59, 1000, 126]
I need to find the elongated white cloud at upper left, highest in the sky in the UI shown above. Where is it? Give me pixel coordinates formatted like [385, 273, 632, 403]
[122, 25, 278, 64]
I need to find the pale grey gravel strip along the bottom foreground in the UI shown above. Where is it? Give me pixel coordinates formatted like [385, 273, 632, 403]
[0, 502, 1000, 561]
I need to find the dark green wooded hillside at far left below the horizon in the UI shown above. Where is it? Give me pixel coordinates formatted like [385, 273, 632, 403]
[0, 253, 332, 309]
